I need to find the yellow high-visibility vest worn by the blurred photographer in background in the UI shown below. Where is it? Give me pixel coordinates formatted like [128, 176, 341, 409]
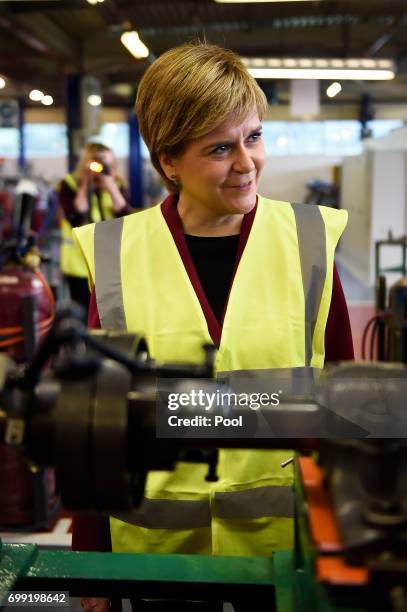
[60, 174, 114, 278]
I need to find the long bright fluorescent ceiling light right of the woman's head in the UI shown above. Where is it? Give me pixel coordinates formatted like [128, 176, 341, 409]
[243, 57, 395, 81]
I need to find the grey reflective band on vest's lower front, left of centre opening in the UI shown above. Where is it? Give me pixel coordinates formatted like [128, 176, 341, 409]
[114, 497, 211, 529]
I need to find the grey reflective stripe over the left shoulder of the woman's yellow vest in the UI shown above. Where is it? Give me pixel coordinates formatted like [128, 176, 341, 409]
[94, 218, 127, 330]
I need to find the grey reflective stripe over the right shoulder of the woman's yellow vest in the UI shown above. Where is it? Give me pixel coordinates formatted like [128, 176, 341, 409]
[291, 204, 326, 365]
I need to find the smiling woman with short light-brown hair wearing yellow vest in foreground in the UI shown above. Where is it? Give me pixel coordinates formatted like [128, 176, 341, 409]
[74, 44, 353, 609]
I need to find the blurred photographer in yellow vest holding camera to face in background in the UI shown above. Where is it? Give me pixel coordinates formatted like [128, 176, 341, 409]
[58, 143, 133, 312]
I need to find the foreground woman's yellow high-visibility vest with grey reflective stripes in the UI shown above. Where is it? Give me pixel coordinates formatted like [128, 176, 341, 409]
[74, 196, 347, 555]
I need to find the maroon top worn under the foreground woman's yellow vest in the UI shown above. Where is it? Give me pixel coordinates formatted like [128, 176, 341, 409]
[72, 195, 354, 551]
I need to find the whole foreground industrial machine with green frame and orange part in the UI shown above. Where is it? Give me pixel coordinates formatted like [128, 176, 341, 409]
[0, 310, 407, 612]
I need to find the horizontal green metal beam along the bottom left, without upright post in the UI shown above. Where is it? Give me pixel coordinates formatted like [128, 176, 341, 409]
[0, 544, 274, 610]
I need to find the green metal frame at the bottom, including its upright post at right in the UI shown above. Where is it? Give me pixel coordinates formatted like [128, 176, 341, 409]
[0, 465, 367, 612]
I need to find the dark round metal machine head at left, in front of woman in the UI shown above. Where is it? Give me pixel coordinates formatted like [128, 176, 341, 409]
[0, 310, 220, 512]
